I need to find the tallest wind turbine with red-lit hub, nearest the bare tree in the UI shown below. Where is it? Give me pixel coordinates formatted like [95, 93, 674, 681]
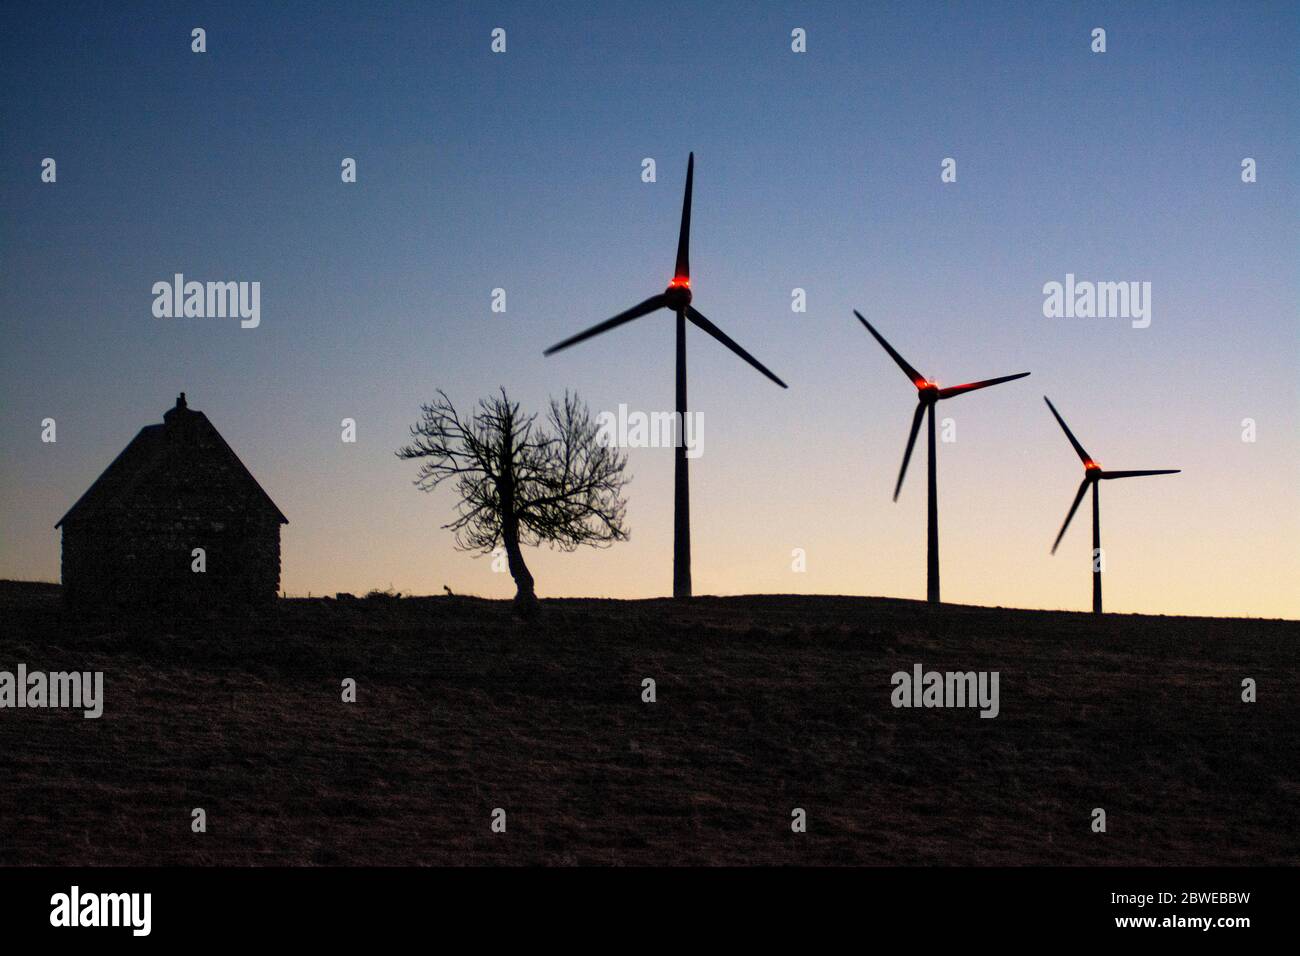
[546, 152, 788, 598]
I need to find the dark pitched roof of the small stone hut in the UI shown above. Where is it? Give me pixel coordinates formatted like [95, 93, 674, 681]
[55, 392, 289, 528]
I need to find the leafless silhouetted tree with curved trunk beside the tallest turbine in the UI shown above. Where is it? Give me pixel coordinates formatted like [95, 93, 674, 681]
[397, 388, 631, 614]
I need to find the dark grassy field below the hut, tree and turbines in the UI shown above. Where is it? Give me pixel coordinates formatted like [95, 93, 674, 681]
[0, 583, 1300, 865]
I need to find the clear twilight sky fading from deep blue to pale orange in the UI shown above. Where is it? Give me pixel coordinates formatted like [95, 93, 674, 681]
[0, 3, 1300, 618]
